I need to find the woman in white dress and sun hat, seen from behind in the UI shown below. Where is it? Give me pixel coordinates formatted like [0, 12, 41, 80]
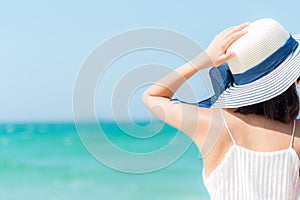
[143, 18, 300, 199]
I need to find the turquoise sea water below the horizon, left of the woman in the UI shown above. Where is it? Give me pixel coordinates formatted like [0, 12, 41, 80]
[0, 123, 209, 200]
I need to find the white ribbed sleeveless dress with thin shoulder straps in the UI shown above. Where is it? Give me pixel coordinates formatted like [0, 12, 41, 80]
[202, 118, 300, 200]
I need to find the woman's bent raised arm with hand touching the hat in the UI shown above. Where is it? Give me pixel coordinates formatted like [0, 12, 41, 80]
[143, 23, 248, 144]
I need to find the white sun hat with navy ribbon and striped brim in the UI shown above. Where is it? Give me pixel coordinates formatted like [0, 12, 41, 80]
[172, 18, 300, 108]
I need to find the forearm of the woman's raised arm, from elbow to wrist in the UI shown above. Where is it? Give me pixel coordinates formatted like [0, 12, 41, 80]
[144, 52, 212, 99]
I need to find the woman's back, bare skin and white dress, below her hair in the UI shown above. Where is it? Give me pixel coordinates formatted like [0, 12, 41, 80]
[202, 112, 299, 199]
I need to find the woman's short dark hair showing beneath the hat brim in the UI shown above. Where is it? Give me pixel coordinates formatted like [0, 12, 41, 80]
[234, 77, 300, 123]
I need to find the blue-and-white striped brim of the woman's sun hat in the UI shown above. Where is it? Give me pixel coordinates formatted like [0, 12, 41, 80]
[212, 35, 300, 108]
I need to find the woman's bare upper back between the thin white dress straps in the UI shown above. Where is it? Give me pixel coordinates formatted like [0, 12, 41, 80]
[226, 112, 300, 154]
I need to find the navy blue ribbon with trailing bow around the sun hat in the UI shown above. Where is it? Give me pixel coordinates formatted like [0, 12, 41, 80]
[171, 35, 298, 108]
